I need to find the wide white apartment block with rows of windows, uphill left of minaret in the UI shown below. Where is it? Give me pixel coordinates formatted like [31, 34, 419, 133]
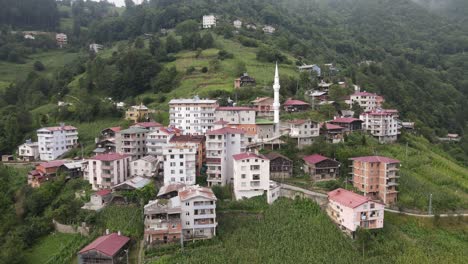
[169, 96, 218, 135]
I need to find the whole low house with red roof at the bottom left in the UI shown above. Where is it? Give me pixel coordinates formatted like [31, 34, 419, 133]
[78, 232, 130, 264]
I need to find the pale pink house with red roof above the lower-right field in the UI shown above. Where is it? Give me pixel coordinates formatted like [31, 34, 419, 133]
[326, 188, 385, 235]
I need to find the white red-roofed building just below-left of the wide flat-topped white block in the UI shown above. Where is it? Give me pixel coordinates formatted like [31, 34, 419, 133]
[146, 127, 180, 161]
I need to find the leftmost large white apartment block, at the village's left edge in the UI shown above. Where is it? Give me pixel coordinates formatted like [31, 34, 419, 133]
[37, 123, 78, 161]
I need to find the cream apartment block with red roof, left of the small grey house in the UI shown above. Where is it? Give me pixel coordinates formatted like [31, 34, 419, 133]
[83, 153, 130, 190]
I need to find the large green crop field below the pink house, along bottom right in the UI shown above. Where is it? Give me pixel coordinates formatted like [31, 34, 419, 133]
[147, 199, 468, 263]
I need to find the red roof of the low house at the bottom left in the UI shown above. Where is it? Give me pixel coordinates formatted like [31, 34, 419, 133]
[79, 233, 130, 257]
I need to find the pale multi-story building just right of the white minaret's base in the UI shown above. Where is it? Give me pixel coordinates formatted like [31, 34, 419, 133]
[289, 119, 320, 148]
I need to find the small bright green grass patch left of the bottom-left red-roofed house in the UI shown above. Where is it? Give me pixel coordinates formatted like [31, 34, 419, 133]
[26, 233, 80, 264]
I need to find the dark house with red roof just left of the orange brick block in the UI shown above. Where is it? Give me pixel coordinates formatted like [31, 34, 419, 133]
[303, 154, 341, 181]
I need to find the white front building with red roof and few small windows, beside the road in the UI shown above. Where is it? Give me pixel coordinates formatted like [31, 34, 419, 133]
[232, 152, 270, 200]
